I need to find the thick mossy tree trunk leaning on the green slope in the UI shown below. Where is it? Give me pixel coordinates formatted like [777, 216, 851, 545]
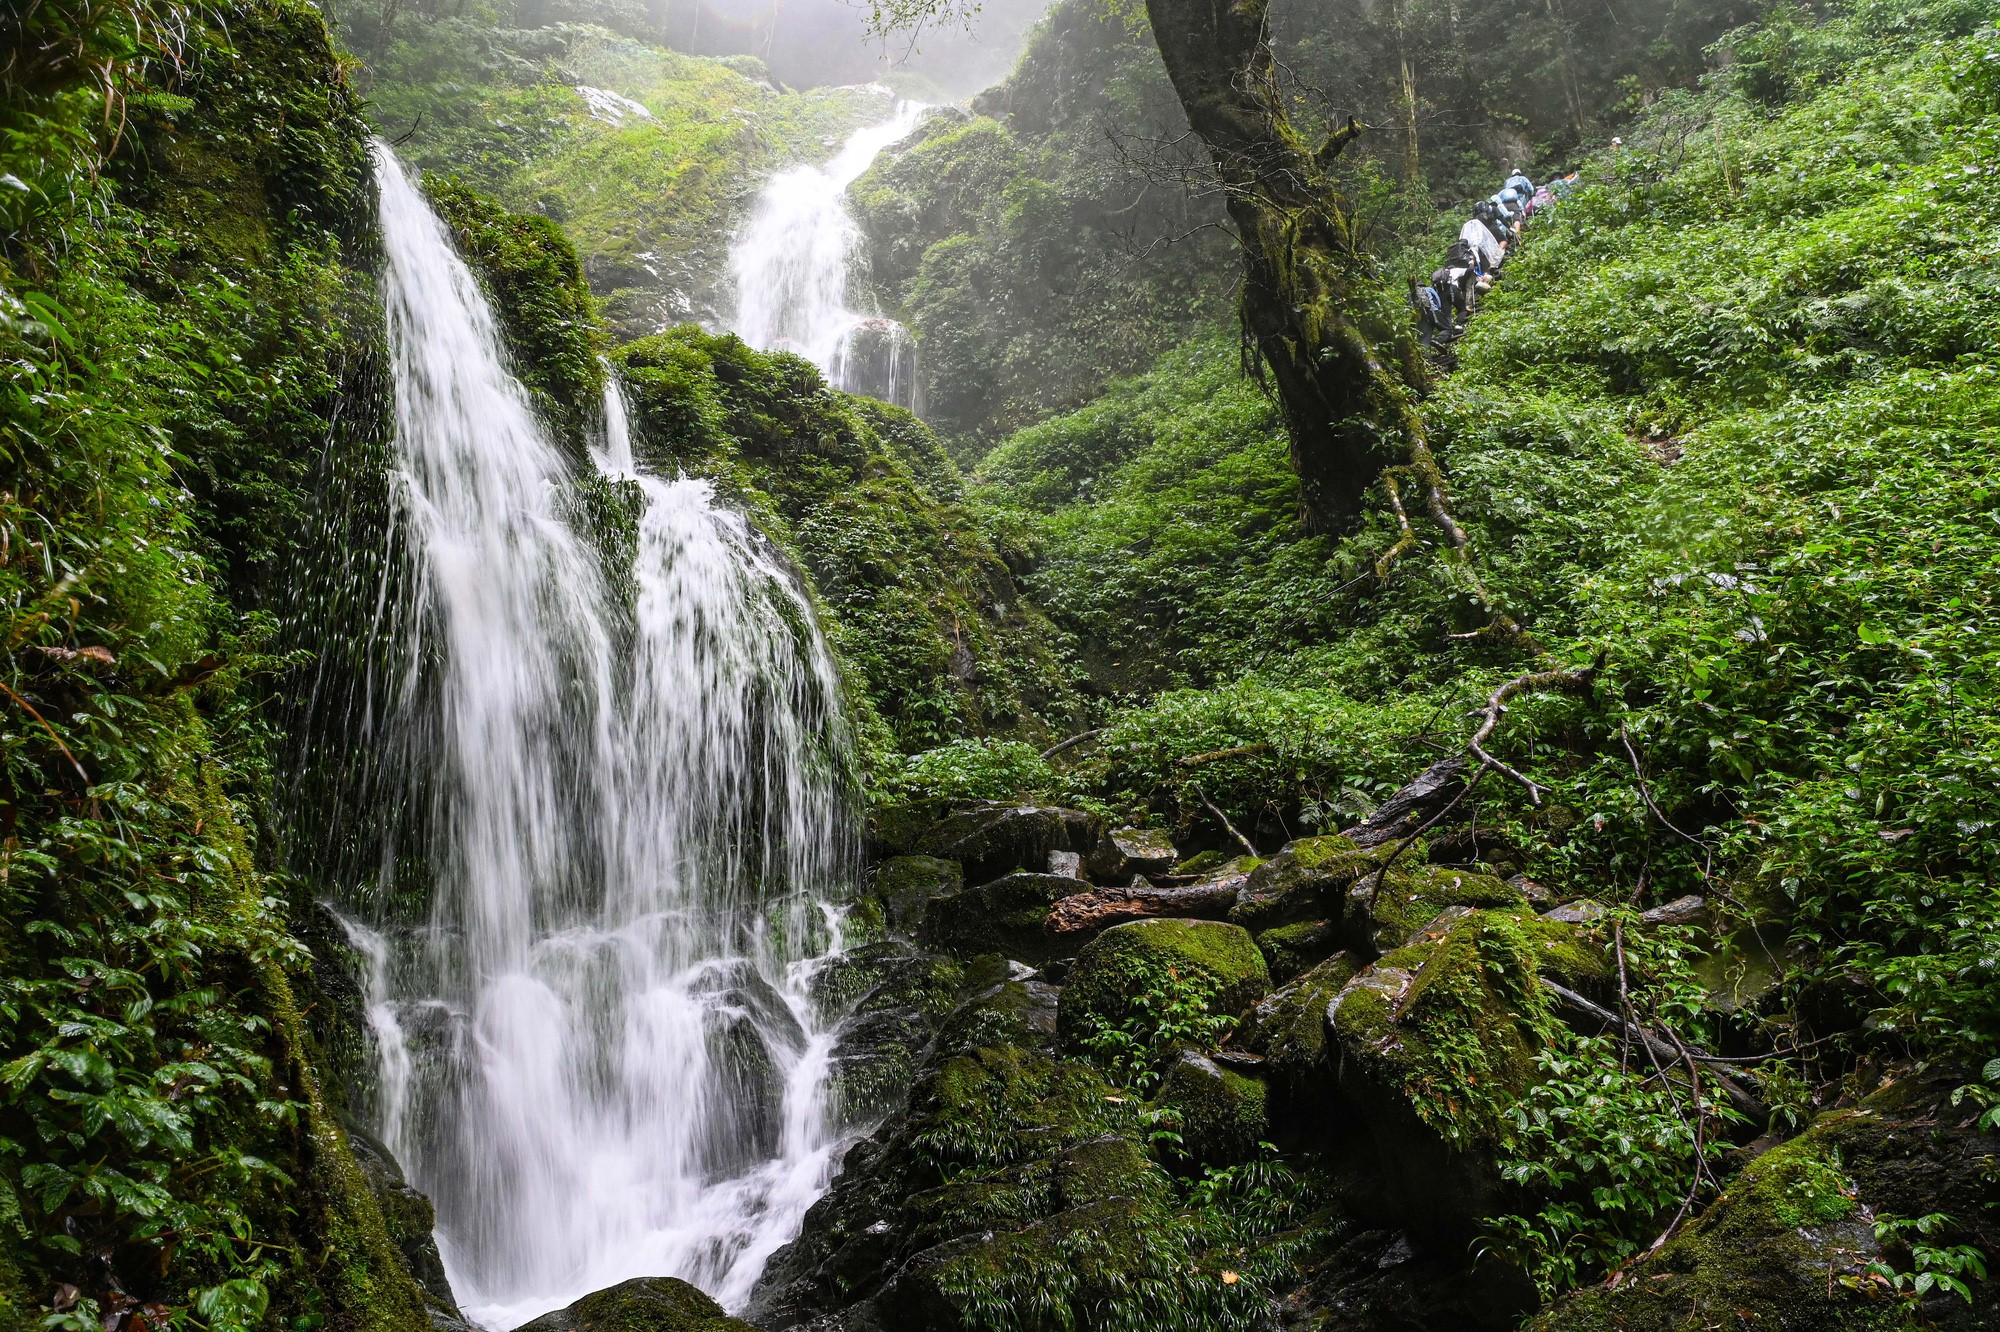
[1146, 0, 1434, 530]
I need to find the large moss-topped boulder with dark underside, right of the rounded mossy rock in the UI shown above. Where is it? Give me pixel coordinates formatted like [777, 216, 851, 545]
[1326, 908, 1610, 1248]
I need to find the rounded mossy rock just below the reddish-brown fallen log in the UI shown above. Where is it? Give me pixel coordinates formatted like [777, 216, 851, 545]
[1058, 920, 1270, 1044]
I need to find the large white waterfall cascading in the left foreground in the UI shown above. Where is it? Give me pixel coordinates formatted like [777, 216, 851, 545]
[350, 142, 854, 1328]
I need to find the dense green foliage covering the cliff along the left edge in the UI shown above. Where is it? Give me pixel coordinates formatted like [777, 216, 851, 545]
[0, 0, 424, 1328]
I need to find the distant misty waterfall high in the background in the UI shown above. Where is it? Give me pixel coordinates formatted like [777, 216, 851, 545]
[730, 102, 930, 410]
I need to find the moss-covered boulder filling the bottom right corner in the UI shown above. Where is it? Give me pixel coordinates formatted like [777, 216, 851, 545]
[1528, 1078, 2000, 1332]
